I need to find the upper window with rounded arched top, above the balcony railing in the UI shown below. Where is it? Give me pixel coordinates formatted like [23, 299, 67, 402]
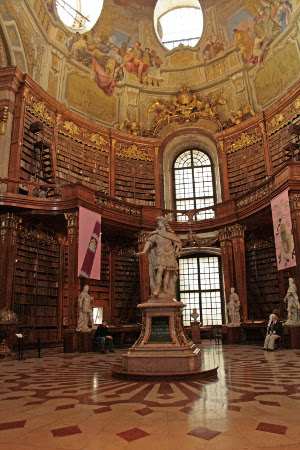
[173, 150, 215, 222]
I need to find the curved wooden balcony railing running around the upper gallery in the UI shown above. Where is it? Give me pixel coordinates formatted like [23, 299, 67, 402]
[0, 162, 300, 224]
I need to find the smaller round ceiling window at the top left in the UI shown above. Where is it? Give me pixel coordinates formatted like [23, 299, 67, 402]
[55, 0, 103, 33]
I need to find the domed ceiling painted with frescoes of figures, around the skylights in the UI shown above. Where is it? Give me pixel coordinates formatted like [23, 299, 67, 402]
[0, 0, 300, 128]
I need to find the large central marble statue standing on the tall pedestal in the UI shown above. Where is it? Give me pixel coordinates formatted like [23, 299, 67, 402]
[136, 216, 182, 297]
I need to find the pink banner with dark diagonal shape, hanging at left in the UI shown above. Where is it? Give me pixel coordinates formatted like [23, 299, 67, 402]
[78, 206, 101, 280]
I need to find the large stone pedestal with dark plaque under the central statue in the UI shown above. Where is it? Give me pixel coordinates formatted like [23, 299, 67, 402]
[112, 296, 217, 380]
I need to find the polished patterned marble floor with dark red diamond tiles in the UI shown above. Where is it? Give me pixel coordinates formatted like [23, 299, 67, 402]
[0, 344, 300, 450]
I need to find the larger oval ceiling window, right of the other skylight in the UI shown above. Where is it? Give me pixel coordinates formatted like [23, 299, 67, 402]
[154, 0, 203, 50]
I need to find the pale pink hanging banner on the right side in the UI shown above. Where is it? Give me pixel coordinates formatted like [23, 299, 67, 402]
[271, 190, 296, 270]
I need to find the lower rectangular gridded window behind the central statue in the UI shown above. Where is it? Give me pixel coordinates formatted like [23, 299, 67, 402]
[178, 255, 224, 326]
